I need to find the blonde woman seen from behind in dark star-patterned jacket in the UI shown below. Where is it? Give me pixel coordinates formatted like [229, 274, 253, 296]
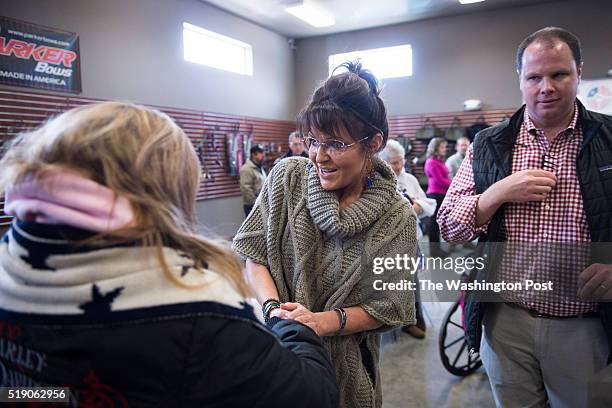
[0, 103, 337, 407]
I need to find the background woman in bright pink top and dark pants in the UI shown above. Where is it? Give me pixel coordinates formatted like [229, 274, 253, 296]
[425, 137, 451, 256]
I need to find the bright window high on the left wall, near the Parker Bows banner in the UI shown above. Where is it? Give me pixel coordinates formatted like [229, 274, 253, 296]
[183, 23, 253, 75]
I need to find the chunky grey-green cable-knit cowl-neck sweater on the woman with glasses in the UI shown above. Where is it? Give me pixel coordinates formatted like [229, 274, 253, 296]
[234, 157, 416, 408]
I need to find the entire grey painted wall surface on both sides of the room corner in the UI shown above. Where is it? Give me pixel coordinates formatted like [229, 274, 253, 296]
[0, 0, 612, 237]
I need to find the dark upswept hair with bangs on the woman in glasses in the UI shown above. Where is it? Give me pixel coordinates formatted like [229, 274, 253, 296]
[296, 61, 389, 153]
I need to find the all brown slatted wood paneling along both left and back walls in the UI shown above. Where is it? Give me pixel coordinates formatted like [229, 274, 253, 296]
[0, 89, 515, 226]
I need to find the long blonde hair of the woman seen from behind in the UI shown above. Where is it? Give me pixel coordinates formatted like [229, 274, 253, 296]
[0, 102, 249, 296]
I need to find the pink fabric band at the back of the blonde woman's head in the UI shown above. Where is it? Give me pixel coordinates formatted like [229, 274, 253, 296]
[4, 170, 134, 232]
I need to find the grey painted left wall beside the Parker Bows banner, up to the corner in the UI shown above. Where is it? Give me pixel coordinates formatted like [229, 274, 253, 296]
[0, 0, 295, 237]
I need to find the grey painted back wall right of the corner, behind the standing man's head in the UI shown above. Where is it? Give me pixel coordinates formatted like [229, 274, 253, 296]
[295, 0, 612, 115]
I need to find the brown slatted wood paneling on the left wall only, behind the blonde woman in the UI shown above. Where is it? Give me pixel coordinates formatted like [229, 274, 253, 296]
[0, 89, 295, 225]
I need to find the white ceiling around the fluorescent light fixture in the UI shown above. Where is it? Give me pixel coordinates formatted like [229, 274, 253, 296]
[201, 0, 553, 38]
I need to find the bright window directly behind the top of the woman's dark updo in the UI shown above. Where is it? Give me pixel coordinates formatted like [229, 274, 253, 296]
[329, 44, 412, 79]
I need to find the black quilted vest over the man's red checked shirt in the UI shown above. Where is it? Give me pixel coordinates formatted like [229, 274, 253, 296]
[464, 101, 612, 362]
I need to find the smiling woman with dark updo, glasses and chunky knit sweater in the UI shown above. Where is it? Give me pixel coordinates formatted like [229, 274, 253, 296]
[234, 62, 416, 408]
